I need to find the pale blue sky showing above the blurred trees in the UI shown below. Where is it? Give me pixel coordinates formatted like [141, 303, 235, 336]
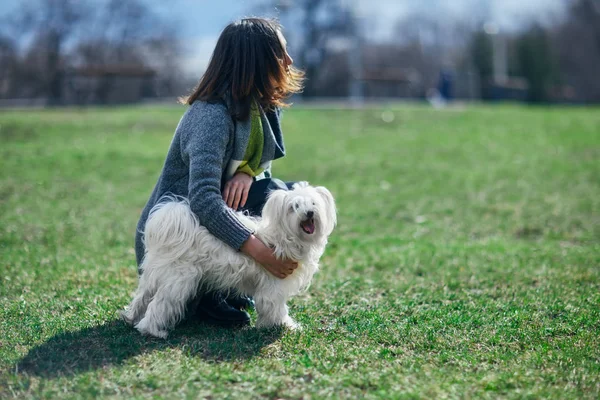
[0, 0, 565, 75]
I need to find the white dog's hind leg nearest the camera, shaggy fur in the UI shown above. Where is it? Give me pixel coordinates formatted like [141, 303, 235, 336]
[135, 267, 200, 339]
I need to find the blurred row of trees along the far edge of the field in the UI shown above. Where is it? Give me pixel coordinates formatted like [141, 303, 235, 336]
[0, 0, 600, 104]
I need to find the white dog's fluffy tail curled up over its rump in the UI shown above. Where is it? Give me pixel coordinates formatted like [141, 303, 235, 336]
[143, 196, 199, 261]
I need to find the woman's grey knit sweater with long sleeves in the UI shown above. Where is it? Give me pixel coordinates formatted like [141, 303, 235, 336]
[136, 101, 285, 264]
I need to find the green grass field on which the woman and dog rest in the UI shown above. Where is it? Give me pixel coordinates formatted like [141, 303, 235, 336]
[0, 105, 600, 399]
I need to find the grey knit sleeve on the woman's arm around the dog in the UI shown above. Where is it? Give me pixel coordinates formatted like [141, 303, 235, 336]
[178, 104, 252, 250]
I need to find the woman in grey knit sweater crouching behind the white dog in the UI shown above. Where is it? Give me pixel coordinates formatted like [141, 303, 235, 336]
[135, 18, 303, 325]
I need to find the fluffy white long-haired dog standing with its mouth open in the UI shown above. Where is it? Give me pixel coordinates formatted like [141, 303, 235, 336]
[122, 182, 336, 338]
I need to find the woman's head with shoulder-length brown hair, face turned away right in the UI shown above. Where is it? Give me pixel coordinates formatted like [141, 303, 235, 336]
[184, 18, 304, 120]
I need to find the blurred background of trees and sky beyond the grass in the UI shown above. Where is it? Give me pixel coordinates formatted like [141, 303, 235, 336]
[0, 0, 600, 106]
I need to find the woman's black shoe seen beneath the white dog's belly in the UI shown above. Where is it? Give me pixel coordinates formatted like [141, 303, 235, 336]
[196, 292, 250, 326]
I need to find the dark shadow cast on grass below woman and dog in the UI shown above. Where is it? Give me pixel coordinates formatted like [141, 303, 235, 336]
[18, 320, 283, 378]
